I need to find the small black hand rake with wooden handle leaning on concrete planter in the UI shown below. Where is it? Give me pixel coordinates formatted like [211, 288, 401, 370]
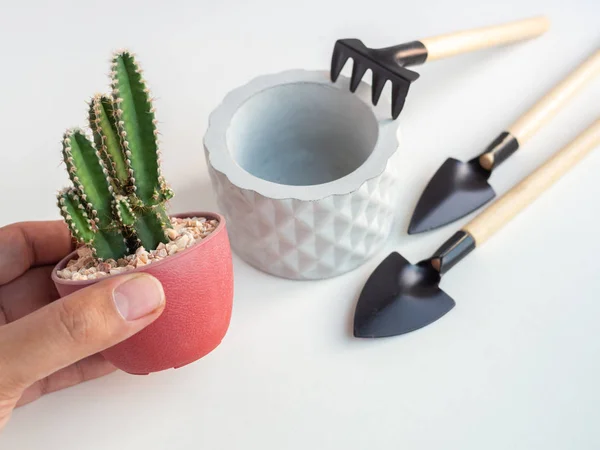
[330, 17, 549, 119]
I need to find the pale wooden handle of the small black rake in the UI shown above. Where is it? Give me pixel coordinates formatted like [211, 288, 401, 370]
[421, 16, 550, 62]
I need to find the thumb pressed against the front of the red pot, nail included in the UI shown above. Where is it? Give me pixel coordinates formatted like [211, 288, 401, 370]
[0, 273, 165, 388]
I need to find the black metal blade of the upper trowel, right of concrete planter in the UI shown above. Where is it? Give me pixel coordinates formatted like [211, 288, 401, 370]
[408, 158, 496, 234]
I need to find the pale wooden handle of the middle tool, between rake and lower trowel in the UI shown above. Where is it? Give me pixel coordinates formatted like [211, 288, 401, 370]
[507, 50, 600, 142]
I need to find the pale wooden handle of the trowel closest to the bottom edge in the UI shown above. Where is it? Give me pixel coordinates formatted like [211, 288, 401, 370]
[463, 119, 600, 245]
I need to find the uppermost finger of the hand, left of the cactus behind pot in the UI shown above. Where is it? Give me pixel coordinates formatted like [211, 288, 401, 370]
[0, 220, 75, 285]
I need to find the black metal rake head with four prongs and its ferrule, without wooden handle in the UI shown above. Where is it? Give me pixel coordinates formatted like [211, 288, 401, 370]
[331, 39, 427, 119]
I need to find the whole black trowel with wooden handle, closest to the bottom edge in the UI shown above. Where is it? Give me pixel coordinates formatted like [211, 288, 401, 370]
[354, 118, 600, 338]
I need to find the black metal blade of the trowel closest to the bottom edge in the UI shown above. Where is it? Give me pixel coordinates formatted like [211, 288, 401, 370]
[354, 252, 455, 338]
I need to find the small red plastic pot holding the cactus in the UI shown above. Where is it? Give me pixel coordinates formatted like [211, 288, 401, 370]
[52, 212, 233, 375]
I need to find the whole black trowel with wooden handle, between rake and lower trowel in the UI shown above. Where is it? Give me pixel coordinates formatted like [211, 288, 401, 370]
[408, 50, 600, 234]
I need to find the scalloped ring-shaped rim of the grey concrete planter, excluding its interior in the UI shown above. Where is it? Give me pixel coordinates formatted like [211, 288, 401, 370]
[204, 69, 400, 201]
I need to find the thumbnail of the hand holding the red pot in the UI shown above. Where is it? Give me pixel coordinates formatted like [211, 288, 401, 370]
[113, 276, 165, 320]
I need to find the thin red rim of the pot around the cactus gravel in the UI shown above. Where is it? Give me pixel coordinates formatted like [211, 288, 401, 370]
[51, 211, 226, 286]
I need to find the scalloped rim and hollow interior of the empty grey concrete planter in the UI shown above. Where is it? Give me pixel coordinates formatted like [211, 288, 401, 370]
[204, 70, 398, 201]
